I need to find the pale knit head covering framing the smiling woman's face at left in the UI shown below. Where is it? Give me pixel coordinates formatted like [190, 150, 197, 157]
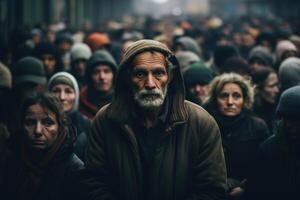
[48, 72, 79, 113]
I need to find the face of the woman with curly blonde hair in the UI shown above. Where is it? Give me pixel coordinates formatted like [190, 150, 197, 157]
[217, 83, 244, 117]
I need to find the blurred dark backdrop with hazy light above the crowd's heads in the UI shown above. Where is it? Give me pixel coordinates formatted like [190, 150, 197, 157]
[0, 0, 300, 38]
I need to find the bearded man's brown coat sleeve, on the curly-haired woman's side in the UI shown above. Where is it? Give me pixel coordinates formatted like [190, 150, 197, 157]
[187, 107, 227, 200]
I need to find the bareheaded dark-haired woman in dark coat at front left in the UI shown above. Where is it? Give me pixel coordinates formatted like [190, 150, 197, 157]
[0, 94, 83, 200]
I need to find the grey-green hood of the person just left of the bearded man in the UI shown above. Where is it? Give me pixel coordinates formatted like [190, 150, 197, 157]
[85, 49, 117, 84]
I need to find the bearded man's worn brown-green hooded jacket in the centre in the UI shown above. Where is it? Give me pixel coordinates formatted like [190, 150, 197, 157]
[82, 40, 226, 200]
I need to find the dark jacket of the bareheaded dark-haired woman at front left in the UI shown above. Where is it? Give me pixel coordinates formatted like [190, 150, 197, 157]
[0, 127, 84, 200]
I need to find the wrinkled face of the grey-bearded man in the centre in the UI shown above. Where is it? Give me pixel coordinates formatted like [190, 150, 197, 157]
[131, 52, 169, 109]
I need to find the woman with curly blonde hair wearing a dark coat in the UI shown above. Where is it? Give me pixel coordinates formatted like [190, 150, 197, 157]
[204, 73, 269, 199]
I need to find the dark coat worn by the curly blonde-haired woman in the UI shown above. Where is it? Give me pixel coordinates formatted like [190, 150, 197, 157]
[204, 109, 269, 193]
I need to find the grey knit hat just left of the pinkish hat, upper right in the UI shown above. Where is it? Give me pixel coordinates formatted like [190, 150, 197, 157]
[248, 46, 273, 67]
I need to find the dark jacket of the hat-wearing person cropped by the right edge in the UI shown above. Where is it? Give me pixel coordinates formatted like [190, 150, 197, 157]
[247, 124, 300, 200]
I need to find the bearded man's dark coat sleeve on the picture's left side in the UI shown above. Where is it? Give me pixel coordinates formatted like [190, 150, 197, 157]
[80, 109, 115, 200]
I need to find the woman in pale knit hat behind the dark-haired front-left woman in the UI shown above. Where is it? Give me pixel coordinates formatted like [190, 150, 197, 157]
[48, 72, 91, 161]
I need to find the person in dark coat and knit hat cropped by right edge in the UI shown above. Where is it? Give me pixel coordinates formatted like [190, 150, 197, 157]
[246, 85, 300, 200]
